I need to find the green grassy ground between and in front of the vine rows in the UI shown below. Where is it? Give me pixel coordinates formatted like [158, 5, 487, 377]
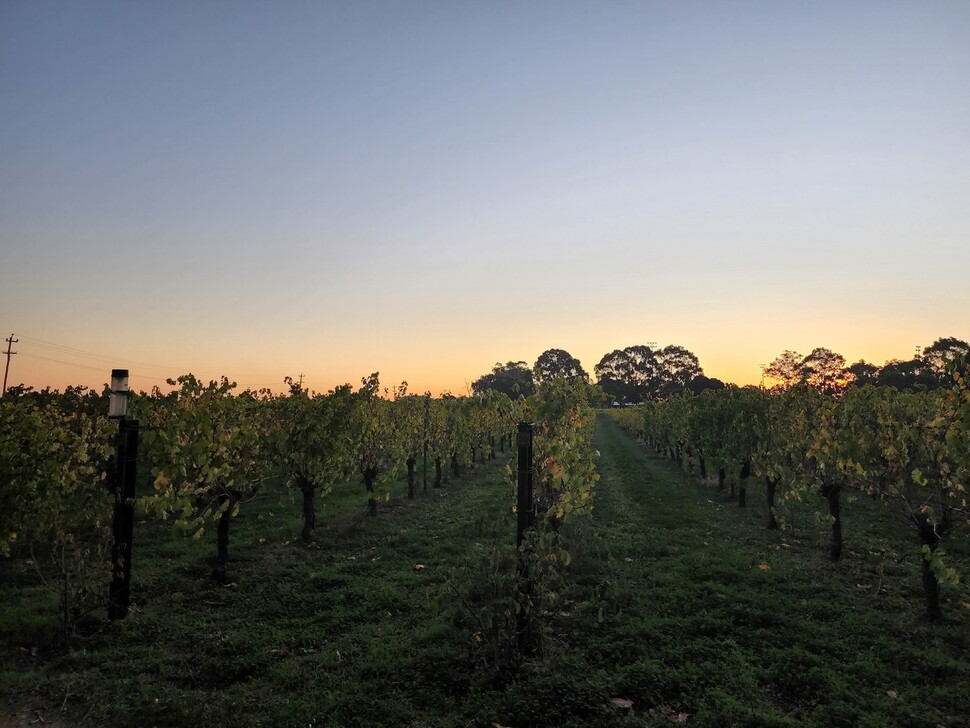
[0, 422, 970, 728]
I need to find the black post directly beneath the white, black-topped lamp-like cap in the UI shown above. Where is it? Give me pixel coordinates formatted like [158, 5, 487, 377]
[108, 418, 138, 619]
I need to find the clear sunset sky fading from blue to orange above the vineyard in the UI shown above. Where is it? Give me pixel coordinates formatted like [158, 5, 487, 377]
[0, 0, 970, 394]
